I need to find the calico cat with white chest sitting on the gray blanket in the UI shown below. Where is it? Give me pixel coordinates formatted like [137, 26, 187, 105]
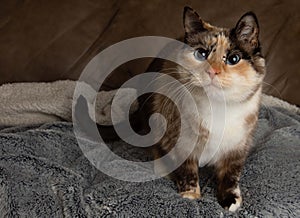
[151, 7, 265, 211]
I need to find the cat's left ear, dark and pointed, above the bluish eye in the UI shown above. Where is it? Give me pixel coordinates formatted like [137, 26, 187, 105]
[183, 6, 210, 34]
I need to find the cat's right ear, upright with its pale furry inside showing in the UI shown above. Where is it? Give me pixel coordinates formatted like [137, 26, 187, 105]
[234, 12, 259, 50]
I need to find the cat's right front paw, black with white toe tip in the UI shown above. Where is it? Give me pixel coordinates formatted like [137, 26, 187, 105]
[218, 187, 242, 212]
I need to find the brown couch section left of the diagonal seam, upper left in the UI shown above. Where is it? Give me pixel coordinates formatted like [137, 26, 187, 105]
[0, 0, 117, 83]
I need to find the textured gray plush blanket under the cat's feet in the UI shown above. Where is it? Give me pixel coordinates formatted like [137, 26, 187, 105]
[0, 107, 300, 217]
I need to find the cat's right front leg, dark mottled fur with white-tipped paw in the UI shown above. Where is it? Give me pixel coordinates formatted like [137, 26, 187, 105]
[215, 152, 246, 211]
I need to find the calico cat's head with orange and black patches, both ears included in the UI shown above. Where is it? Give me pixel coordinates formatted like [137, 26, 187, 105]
[180, 7, 265, 102]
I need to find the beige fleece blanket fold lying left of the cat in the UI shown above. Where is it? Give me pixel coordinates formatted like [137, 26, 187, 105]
[0, 80, 138, 126]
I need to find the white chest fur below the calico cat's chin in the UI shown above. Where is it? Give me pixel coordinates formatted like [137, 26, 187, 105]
[191, 87, 260, 166]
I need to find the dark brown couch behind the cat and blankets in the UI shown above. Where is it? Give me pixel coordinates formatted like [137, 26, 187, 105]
[0, 0, 300, 105]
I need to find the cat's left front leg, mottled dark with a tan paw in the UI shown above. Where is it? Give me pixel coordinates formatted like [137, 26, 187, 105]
[173, 158, 201, 199]
